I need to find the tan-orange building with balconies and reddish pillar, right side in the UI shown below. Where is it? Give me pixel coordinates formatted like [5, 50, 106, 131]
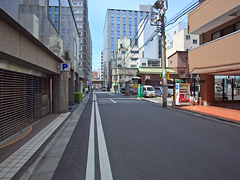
[188, 0, 240, 104]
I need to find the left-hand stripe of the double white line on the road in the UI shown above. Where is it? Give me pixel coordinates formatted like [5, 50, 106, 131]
[86, 93, 96, 180]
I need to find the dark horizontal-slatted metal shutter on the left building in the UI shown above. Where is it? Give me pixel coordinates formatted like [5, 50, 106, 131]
[0, 69, 49, 142]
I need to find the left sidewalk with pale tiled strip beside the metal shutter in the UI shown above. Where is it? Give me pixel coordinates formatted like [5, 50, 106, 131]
[0, 95, 89, 180]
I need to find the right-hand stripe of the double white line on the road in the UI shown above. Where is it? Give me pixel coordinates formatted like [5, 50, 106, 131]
[95, 98, 113, 180]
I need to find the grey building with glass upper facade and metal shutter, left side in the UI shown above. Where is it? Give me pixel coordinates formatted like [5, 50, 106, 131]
[0, 0, 81, 143]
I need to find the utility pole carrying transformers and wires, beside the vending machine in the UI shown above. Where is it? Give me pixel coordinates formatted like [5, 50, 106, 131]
[149, 0, 168, 107]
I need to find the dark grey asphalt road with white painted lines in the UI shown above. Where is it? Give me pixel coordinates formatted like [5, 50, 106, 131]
[28, 92, 240, 180]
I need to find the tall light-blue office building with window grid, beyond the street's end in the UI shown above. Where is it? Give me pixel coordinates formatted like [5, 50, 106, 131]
[103, 5, 151, 85]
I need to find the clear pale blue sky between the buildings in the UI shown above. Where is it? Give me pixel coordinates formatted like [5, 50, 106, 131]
[88, 0, 196, 71]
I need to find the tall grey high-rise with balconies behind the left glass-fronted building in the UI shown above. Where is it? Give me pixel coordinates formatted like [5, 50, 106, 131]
[72, 0, 92, 84]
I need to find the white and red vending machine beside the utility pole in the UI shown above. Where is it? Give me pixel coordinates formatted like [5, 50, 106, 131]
[175, 83, 190, 106]
